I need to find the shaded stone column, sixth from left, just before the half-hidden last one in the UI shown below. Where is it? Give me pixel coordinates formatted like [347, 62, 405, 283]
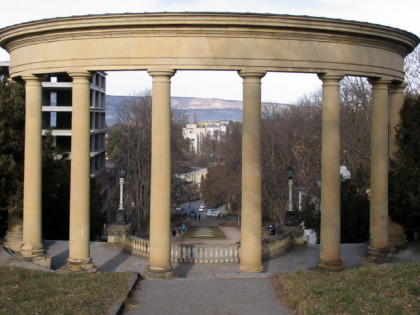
[362, 79, 390, 265]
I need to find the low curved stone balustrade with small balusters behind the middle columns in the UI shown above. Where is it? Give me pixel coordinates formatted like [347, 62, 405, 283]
[123, 231, 293, 264]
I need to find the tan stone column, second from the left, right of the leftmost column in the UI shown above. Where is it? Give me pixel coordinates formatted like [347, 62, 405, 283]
[66, 72, 94, 270]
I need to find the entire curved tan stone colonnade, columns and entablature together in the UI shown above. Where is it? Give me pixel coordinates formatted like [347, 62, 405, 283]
[0, 13, 419, 278]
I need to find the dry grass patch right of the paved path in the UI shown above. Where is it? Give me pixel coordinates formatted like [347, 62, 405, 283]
[273, 263, 420, 314]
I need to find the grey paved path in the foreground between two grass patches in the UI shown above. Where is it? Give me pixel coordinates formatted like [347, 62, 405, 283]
[124, 278, 293, 315]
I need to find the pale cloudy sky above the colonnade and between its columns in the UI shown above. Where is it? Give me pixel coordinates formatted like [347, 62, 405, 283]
[0, 0, 420, 103]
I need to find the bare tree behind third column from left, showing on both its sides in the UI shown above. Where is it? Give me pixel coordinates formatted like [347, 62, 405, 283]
[108, 91, 190, 236]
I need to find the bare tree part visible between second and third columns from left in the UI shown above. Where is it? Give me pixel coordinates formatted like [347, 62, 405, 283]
[109, 91, 152, 234]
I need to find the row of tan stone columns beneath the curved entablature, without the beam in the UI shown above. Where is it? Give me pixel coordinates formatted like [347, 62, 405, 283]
[21, 70, 404, 278]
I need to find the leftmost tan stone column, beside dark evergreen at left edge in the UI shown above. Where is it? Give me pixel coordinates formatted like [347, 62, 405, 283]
[21, 76, 51, 268]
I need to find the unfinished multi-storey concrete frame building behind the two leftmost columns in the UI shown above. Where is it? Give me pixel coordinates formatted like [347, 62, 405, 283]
[42, 72, 107, 196]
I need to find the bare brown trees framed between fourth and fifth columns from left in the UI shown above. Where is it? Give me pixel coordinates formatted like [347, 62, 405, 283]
[261, 93, 321, 223]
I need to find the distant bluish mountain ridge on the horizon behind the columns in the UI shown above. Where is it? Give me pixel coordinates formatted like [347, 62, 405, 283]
[105, 95, 289, 126]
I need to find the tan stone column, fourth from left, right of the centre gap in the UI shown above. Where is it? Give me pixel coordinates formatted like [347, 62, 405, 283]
[239, 71, 265, 273]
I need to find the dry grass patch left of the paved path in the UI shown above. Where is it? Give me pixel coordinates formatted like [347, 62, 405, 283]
[0, 267, 131, 314]
